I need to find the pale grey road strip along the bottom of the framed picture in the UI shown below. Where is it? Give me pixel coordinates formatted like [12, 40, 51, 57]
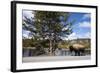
[22, 55, 91, 63]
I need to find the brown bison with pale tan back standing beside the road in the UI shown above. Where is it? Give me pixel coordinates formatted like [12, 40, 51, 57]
[69, 44, 85, 56]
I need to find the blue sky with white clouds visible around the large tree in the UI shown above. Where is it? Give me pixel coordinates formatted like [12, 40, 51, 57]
[23, 10, 91, 40]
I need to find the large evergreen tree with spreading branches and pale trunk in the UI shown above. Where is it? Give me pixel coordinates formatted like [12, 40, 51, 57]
[23, 11, 73, 55]
